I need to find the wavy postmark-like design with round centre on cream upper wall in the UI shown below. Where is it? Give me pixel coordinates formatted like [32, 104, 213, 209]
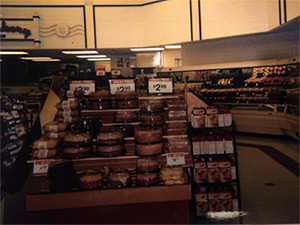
[40, 24, 84, 38]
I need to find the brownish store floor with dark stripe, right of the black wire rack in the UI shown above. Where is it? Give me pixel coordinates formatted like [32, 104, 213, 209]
[237, 136, 299, 224]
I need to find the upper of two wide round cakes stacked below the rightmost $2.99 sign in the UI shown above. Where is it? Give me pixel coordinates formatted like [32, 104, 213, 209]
[134, 127, 163, 144]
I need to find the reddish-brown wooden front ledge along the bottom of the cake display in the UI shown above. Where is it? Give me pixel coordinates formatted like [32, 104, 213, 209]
[26, 180, 191, 211]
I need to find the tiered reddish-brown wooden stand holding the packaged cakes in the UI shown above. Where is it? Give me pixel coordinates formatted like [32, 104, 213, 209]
[26, 93, 193, 224]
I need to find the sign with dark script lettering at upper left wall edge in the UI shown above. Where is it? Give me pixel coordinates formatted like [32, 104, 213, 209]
[0, 16, 40, 43]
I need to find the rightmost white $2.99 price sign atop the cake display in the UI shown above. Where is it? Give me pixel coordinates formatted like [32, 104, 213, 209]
[148, 78, 173, 94]
